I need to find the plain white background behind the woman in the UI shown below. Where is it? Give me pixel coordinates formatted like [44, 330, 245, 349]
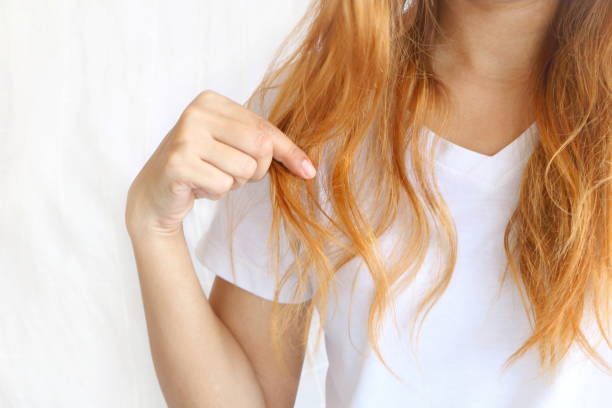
[0, 0, 326, 408]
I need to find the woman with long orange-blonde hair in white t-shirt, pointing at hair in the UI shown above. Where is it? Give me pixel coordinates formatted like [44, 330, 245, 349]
[126, 0, 612, 408]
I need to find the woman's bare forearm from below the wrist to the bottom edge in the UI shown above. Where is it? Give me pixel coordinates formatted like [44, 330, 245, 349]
[126, 226, 264, 408]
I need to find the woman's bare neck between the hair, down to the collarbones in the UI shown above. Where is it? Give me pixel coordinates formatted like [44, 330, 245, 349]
[434, 0, 559, 86]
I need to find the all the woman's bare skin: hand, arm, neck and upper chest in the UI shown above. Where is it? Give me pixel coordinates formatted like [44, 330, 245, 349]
[125, 0, 556, 408]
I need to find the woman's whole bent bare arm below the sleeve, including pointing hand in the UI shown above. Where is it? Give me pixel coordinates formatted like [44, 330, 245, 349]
[125, 91, 315, 408]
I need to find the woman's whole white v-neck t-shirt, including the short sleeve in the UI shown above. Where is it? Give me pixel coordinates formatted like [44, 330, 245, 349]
[196, 123, 612, 408]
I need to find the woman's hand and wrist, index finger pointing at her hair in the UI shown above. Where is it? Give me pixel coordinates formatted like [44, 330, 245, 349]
[125, 90, 315, 234]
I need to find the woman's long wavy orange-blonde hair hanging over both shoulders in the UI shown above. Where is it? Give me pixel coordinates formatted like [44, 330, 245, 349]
[247, 0, 612, 376]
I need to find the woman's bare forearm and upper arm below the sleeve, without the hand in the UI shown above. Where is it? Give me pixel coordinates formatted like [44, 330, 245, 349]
[132, 225, 308, 408]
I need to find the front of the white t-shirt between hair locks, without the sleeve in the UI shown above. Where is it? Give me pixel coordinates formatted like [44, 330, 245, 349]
[316, 125, 610, 408]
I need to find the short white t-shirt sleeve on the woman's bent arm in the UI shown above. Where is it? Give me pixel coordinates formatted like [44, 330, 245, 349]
[195, 174, 313, 303]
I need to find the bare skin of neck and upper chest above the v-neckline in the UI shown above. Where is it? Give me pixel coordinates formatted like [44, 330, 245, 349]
[428, 0, 559, 156]
